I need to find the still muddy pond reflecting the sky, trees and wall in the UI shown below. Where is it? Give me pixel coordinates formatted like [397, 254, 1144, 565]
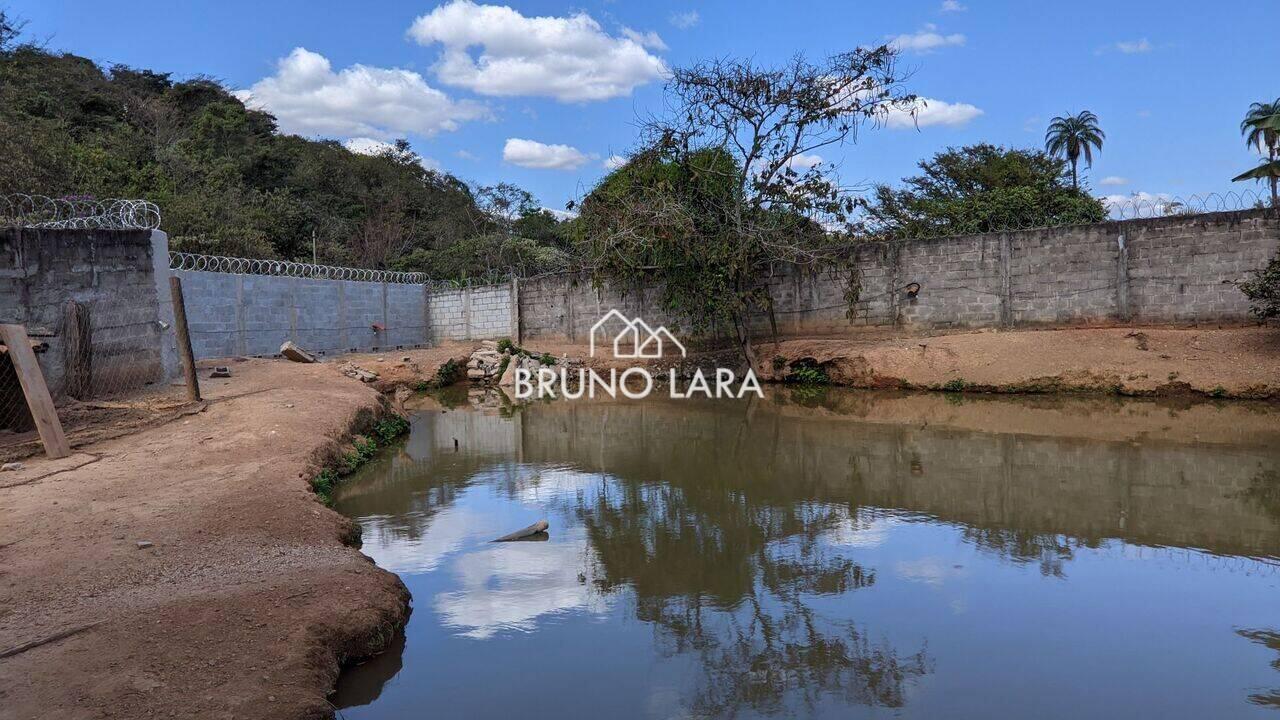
[332, 389, 1280, 719]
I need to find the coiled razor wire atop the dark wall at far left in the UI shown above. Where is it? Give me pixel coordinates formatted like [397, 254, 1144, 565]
[0, 193, 160, 231]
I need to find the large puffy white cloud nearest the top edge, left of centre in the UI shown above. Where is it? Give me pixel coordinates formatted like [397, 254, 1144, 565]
[408, 0, 667, 102]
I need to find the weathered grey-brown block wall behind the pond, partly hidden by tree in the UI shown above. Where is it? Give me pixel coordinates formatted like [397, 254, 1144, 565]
[520, 210, 1280, 342]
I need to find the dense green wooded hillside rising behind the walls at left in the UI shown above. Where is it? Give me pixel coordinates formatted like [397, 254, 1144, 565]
[0, 35, 576, 279]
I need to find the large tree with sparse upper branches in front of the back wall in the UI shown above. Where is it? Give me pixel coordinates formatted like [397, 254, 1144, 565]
[575, 46, 918, 365]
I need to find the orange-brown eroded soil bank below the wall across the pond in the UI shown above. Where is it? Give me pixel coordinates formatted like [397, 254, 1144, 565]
[538, 325, 1280, 400]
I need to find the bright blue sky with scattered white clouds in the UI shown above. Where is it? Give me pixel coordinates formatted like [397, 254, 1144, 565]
[10, 0, 1280, 208]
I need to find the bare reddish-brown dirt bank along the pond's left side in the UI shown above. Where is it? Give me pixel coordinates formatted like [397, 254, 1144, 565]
[0, 347, 471, 719]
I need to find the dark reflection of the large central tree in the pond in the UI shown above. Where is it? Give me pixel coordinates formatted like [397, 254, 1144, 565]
[575, 479, 931, 717]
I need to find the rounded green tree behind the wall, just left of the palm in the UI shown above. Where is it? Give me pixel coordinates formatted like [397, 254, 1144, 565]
[864, 143, 1107, 237]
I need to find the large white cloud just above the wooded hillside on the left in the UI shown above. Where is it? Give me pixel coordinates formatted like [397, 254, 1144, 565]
[236, 47, 488, 140]
